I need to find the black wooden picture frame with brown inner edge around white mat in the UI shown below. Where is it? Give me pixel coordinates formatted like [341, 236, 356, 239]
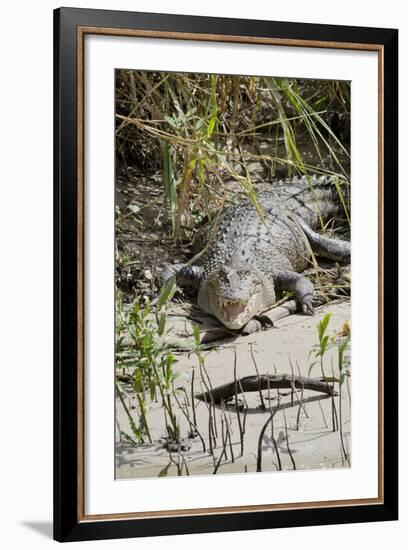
[54, 8, 398, 541]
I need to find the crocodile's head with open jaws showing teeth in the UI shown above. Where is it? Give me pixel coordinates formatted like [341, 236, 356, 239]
[199, 267, 265, 330]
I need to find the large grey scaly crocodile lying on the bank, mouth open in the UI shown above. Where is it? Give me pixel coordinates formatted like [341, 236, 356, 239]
[161, 176, 350, 332]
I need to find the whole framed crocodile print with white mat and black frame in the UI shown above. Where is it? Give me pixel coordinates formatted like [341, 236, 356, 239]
[54, 8, 398, 541]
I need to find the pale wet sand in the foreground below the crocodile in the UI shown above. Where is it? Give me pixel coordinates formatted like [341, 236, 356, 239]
[116, 301, 351, 479]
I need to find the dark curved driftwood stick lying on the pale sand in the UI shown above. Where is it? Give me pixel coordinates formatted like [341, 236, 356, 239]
[195, 374, 337, 405]
